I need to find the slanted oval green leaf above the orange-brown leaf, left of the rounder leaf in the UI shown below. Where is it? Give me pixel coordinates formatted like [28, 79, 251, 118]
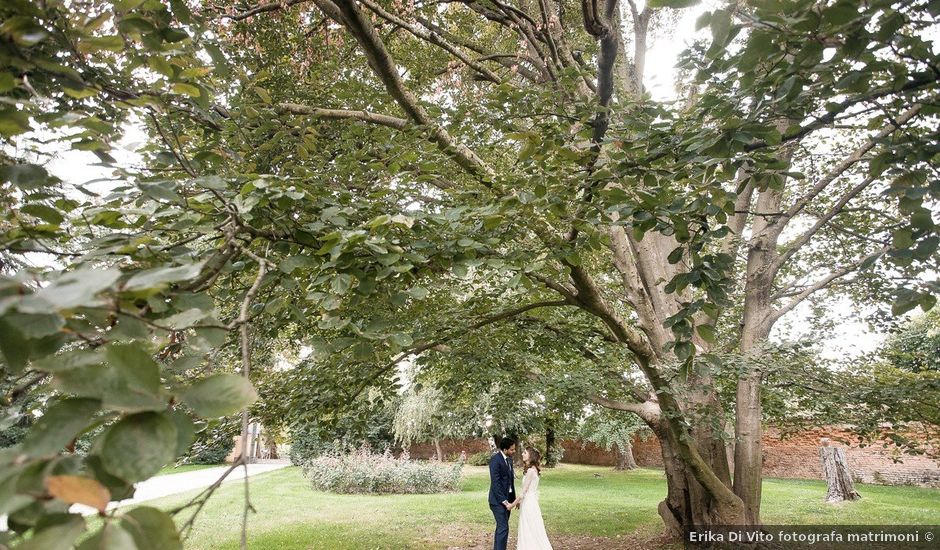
[22, 398, 101, 457]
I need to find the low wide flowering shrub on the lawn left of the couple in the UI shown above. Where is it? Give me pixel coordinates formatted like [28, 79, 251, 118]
[303, 446, 463, 494]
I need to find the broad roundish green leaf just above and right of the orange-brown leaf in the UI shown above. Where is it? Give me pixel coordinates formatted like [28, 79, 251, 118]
[99, 412, 177, 484]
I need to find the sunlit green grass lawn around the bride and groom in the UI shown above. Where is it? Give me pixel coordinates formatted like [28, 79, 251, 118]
[141, 465, 940, 550]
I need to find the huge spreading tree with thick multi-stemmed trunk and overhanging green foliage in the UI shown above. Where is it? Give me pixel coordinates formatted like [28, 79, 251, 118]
[0, 0, 940, 548]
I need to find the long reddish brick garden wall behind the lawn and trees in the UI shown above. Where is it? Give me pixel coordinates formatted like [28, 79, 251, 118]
[410, 427, 940, 488]
